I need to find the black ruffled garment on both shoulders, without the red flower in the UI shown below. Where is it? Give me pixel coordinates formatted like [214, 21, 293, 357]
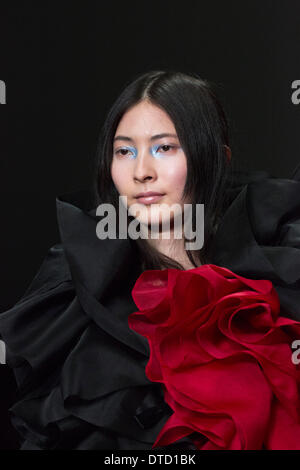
[0, 165, 300, 452]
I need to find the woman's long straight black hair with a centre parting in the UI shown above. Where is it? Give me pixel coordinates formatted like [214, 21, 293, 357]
[93, 70, 232, 269]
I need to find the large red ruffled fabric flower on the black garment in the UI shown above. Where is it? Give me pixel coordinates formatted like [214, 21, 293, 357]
[129, 264, 300, 450]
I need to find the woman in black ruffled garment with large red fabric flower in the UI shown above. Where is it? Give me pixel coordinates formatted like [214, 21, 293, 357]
[0, 71, 300, 451]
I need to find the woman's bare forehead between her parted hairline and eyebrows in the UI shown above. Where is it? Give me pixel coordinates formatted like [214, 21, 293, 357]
[116, 101, 176, 137]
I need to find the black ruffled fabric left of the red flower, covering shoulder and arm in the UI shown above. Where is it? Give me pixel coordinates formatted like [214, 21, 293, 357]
[0, 191, 193, 450]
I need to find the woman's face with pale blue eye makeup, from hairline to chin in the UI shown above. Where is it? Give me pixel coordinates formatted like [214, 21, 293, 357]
[111, 101, 189, 229]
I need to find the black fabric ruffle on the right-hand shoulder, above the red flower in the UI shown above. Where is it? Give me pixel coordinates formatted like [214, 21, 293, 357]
[211, 167, 300, 321]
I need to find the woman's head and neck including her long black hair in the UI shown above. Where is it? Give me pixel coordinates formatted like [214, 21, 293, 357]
[95, 72, 231, 268]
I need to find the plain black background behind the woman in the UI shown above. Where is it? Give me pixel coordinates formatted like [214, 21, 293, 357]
[0, 0, 300, 449]
